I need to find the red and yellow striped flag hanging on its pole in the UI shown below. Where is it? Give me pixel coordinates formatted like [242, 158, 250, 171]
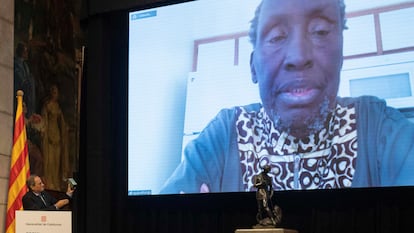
[6, 90, 30, 233]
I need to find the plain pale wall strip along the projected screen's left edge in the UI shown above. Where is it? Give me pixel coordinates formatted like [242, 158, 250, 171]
[128, 3, 193, 193]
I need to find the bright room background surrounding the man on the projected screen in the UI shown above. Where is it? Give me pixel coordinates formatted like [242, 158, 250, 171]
[128, 0, 414, 196]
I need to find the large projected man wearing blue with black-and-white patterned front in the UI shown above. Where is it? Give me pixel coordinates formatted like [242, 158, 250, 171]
[161, 0, 414, 193]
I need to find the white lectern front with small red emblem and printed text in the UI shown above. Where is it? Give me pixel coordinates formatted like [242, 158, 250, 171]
[16, 210, 72, 233]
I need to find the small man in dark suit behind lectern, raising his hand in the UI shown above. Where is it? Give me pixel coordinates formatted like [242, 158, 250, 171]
[22, 175, 75, 210]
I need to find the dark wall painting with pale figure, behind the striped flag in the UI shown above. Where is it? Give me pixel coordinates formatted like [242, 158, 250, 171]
[14, 0, 85, 191]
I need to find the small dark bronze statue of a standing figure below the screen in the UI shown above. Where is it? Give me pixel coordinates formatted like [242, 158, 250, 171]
[253, 165, 282, 228]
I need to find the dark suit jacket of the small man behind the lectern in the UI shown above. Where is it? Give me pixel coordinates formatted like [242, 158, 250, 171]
[22, 191, 57, 210]
